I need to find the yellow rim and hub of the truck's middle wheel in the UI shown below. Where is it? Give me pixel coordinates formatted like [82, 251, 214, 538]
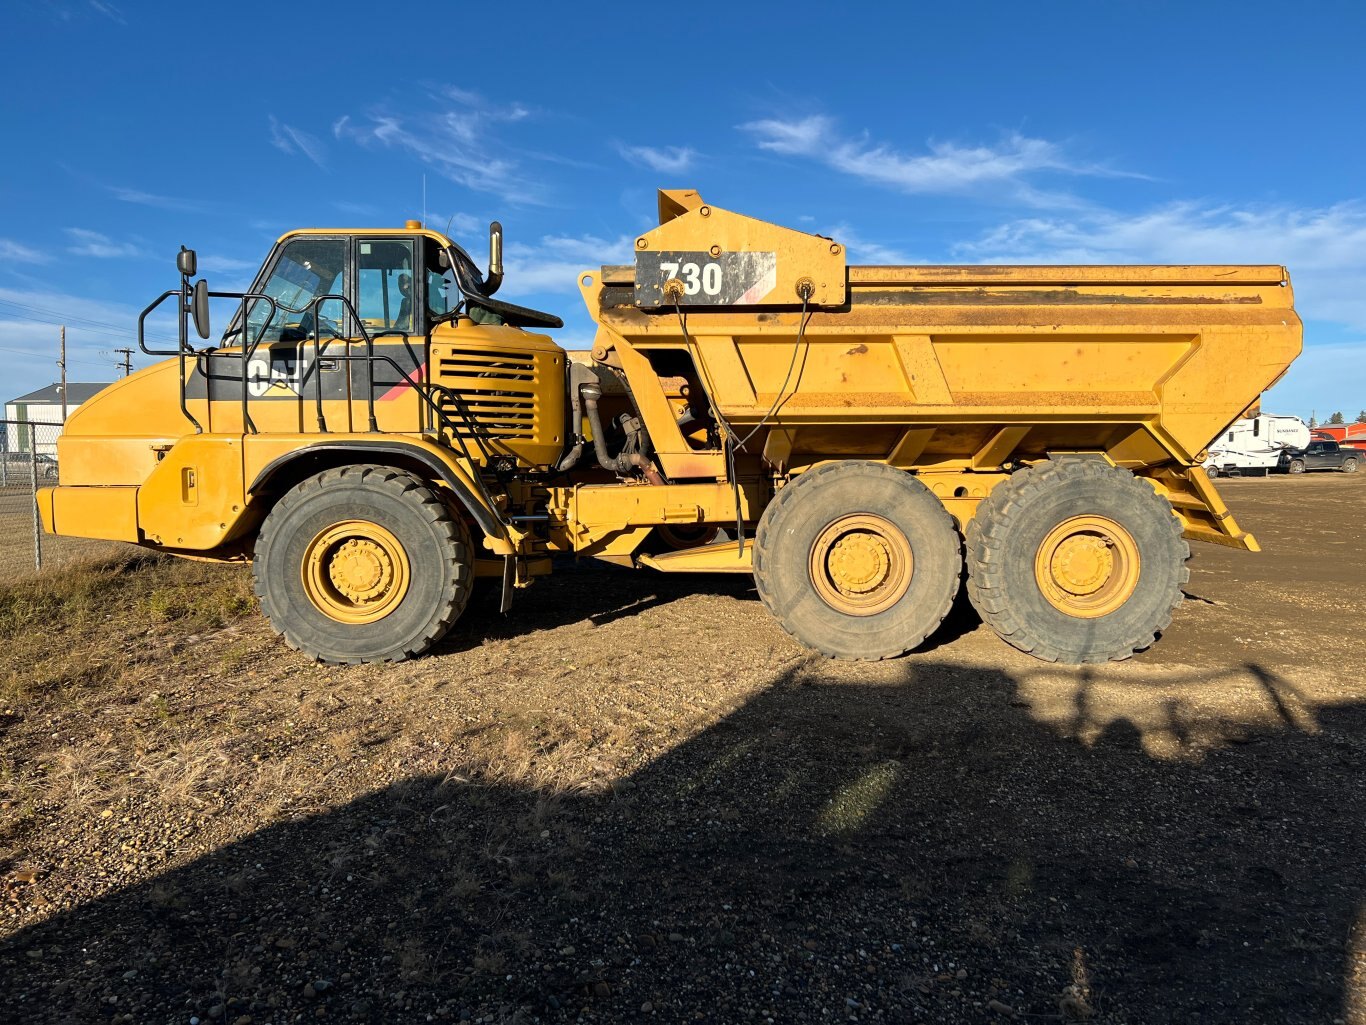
[810, 513, 915, 616]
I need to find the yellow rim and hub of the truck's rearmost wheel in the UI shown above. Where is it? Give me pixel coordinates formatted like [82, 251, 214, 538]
[1034, 517, 1139, 619]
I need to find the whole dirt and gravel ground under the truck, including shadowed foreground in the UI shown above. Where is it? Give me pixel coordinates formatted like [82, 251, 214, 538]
[0, 474, 1366, 1025]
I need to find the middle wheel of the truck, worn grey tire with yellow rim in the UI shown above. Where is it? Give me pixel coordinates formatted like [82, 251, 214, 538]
[754, 461, 963, 661]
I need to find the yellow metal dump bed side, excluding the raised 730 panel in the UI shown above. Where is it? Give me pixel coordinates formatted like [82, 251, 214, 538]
[583, 267, 1300, 467]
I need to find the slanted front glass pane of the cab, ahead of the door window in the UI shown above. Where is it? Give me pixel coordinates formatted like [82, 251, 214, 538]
[247, 238, 347, 343]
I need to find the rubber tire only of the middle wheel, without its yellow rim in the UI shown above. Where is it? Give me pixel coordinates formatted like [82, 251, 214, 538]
[754, 461, 963, 661]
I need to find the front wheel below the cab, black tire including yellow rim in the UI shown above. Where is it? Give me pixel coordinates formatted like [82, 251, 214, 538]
[253, 465, 474, 663]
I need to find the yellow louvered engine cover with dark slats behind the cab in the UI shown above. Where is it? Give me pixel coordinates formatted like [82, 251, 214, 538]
[432, 328, 566, 466]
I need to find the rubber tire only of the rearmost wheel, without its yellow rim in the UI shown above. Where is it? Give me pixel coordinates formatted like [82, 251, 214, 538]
[967, 456, 1190, 664]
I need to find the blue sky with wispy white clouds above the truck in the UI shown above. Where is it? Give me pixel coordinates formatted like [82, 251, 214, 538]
[0, 0, 1366, 418]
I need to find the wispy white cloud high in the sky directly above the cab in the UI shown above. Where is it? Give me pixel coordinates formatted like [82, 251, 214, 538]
[332, 86, 545, 204]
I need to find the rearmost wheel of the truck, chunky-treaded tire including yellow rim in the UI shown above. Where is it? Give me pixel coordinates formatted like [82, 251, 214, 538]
[967, 456, 1190, 664]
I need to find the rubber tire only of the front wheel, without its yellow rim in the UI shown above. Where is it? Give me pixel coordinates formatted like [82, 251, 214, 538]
[253, 465, 474, 664]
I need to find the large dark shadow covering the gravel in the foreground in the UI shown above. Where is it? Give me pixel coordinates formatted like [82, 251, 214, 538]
[0, 660, 1366, 1025]
